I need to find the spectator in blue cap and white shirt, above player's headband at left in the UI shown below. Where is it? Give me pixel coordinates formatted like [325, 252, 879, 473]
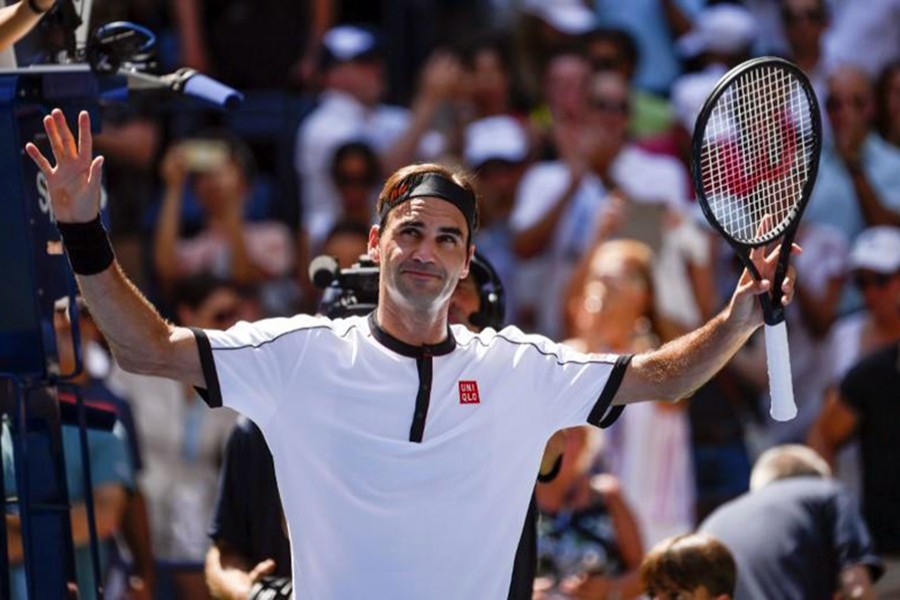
[295, 25, 462, 250]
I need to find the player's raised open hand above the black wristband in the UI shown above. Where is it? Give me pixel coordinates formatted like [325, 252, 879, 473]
[25, 108, 103, 223]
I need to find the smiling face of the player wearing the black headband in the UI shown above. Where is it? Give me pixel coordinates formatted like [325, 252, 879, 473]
[369, 198, 474, 313]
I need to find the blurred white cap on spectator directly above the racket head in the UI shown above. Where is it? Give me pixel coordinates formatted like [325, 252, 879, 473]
[676, 4, 757, 57]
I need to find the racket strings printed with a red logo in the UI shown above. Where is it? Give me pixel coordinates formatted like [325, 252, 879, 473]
[700, 66, 816, 245]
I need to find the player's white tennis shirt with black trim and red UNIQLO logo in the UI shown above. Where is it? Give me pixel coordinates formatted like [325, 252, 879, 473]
[195, 315, 629, 600]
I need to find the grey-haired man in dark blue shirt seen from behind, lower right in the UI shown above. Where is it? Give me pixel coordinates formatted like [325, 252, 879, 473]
[700, 445, 881, 600]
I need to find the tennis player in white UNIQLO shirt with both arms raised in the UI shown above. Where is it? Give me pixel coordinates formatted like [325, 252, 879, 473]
[26, 110, 793, 599]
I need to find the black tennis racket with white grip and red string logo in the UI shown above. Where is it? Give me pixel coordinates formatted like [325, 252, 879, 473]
[691, 57, 822, 421]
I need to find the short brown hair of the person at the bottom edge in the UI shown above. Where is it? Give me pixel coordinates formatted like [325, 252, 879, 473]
[641, 533, 737, 597]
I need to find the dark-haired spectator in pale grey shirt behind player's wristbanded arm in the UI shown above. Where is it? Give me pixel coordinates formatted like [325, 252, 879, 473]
[111, 276, 243, 600]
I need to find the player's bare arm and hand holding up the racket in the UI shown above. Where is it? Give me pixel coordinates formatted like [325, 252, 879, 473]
[613, 241, 800, 404]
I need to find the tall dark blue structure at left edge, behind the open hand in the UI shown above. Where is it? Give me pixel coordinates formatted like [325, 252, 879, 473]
[0, 65, 128, 598]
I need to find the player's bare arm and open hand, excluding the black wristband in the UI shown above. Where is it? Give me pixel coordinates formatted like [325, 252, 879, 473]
[25, 109, 206, 387]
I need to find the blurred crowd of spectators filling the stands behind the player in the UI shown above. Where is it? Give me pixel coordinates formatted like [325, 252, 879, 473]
[7, 0, 900, 599]
